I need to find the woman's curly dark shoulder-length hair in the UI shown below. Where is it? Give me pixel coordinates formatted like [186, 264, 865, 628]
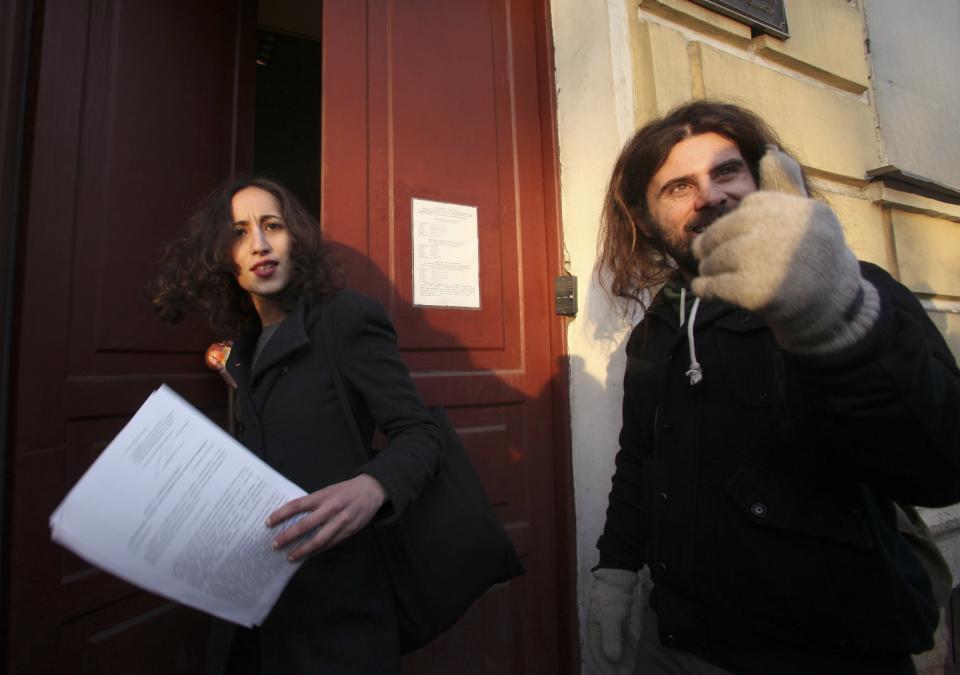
[153, 176, 342, 338]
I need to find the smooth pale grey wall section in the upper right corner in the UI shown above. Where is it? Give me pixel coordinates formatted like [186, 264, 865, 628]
[864, 0, 960, 189]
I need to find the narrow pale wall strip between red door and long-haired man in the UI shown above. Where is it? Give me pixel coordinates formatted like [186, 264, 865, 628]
[551, 0, 634, 673]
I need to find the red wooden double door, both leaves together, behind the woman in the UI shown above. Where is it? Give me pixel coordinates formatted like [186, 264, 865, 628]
[7, 0, 576, 675]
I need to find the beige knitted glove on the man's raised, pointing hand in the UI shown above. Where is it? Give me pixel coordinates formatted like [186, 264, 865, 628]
[692, 146, 880, 354]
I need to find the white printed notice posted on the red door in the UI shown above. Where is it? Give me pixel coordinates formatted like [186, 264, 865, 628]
[412, 199, 480, 309]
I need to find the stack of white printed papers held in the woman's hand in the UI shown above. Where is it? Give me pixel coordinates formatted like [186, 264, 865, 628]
[50, 385, 305, 626]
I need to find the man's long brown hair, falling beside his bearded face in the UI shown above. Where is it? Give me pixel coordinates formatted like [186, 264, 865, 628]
[596, 100, 816, 307]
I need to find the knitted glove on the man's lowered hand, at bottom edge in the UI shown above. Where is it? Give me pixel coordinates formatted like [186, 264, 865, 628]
[587, 568, 639, 675]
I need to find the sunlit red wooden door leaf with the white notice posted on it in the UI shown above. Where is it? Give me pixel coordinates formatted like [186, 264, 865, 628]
[321, 0, 576, 675]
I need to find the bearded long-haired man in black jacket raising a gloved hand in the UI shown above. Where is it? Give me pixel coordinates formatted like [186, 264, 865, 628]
[588, 101, 960, 675]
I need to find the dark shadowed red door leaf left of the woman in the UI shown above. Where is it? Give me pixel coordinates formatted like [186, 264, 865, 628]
[7, 0, 254, 675]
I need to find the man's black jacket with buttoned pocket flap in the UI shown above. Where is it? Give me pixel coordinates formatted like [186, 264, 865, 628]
[598, 263, 960, 674]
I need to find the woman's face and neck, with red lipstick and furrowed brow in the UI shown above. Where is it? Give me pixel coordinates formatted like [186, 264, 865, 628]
[231, 187, 290, 325]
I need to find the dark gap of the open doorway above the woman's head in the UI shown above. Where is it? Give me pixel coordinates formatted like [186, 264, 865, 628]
[253, 0, 323, 216]
